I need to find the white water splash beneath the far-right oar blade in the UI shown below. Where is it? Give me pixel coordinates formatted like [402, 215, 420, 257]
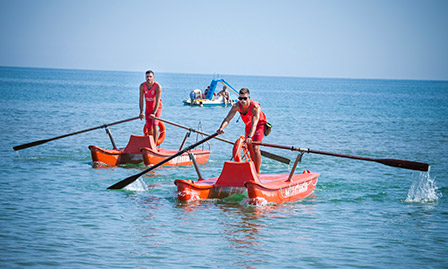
[406, 171, 442, 203]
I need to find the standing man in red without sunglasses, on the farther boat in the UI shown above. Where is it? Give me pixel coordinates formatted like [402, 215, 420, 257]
[139, 70, 162, 143]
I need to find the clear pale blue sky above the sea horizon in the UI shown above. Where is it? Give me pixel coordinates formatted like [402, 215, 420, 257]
[0, 0, 448, 80]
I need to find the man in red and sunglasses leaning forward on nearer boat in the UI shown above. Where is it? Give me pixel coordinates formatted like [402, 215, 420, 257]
[216, 88, 266, 173]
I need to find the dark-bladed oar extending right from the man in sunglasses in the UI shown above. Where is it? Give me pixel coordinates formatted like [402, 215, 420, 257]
[253, 142, 429, 171]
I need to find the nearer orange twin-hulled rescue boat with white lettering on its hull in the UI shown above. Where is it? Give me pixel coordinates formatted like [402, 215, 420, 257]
[174, 137, 320, 204]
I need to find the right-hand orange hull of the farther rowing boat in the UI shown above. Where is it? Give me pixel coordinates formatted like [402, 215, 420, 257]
[141, 147, 211, 166]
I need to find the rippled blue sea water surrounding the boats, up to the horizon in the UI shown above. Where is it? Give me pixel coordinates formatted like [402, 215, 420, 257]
[0, 67, 448, 268]
